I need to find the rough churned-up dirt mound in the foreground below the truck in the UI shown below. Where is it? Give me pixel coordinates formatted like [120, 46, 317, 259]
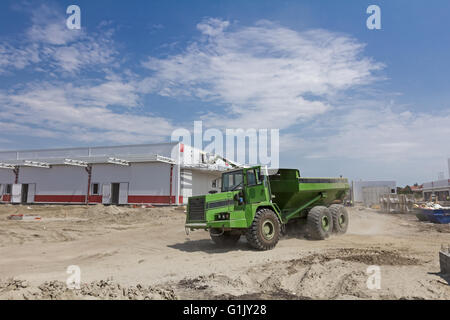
[170, 248, 421, 300]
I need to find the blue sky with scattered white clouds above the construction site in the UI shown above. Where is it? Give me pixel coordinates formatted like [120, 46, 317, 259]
[0, 0, 450, 184]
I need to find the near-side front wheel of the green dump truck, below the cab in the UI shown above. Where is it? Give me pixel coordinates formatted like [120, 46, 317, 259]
[245, 209, 281, 250]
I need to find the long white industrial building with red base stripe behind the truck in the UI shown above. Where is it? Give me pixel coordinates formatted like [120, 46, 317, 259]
[0, 142, 231, 205]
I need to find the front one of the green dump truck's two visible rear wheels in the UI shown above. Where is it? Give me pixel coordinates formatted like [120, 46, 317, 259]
[306, 206, 333, 240]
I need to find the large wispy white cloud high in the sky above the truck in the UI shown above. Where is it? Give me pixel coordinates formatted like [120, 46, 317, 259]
[143, 19, 382, 129]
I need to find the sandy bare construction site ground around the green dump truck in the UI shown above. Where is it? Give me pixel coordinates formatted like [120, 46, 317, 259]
[0, 205, 450, 299]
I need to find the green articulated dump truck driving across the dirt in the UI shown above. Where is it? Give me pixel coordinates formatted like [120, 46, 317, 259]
[185, 166, 349, 250]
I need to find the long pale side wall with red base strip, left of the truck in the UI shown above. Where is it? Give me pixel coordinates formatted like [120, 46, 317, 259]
[0, 162, 183, 204]
